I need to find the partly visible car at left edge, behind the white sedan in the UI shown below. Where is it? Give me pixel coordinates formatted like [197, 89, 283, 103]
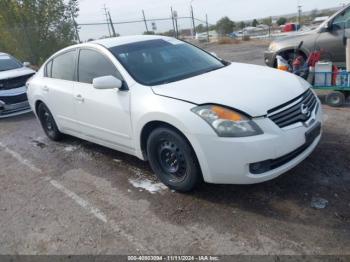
[0, 53, 35, 118]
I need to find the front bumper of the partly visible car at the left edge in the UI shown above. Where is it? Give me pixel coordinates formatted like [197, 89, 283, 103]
[0, 87, 31, 118]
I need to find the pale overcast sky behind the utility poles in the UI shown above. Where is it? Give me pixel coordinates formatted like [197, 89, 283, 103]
[77, 0, 350, 40]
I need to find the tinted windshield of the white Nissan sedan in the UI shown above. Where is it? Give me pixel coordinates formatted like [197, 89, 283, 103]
[110, 39, 225, 86]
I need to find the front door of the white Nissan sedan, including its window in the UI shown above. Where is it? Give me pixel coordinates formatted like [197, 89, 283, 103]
[74, 48, 133, 152]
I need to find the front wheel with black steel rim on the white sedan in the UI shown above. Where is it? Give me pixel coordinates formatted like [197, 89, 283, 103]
[147, 127, 202, 192]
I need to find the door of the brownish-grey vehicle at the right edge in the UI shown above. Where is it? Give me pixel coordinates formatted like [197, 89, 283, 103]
[316, 9, 350, 65]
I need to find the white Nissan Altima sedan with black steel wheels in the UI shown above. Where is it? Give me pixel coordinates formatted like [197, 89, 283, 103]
[27, 36, 322, 191]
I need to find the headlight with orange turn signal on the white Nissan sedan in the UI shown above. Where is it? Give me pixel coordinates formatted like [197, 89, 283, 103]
[192, 105, 263, 137]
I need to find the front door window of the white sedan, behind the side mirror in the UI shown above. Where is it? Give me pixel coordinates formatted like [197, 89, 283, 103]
[78, 49, 122, 84]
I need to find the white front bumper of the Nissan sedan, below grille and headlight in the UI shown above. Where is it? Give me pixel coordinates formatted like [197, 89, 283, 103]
[194, 101, 322, 184]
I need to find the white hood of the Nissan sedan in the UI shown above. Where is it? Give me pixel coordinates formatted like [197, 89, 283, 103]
[152, 63, 310, 117]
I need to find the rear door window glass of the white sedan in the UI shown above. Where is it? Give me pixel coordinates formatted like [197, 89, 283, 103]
[51, 50, 75, 81]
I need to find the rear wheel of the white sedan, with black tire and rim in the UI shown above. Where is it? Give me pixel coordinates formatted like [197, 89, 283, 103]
[38, 103, 63, 141]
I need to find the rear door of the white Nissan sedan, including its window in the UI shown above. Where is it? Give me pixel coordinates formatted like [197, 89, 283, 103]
[40, 49, 77, 130]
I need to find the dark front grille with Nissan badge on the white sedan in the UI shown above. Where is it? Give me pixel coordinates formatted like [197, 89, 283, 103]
[267, 89, 317, 128]
